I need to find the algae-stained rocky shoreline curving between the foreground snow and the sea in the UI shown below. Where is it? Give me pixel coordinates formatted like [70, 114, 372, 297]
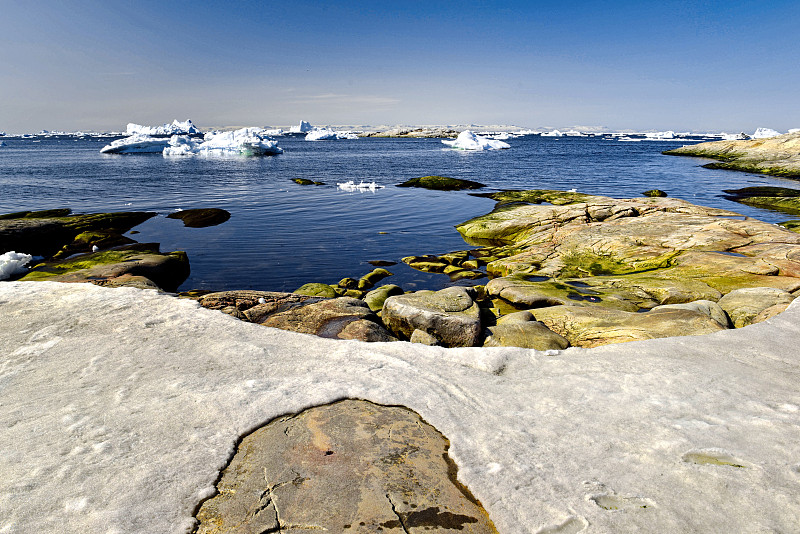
[7, 190, 800, 351]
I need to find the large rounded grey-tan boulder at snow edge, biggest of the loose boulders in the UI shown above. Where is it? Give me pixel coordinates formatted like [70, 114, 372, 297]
[381, 287, 481, 347]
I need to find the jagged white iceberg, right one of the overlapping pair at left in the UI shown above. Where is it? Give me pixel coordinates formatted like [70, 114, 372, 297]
[163, 128, 283, 157]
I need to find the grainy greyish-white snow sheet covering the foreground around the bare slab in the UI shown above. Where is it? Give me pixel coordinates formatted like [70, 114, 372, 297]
[0, 282, 800, 533]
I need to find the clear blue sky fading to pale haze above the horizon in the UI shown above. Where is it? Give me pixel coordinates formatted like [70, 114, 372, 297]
[0, 0, 800, 132]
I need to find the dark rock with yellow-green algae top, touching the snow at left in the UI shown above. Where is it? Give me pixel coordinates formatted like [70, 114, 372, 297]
[22, 247, 189, 291]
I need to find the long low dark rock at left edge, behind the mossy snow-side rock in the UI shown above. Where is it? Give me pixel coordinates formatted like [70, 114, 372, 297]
[0, 209, 156, 258]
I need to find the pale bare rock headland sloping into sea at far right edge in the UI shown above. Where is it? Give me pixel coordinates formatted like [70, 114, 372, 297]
[663, 132, 800, 178]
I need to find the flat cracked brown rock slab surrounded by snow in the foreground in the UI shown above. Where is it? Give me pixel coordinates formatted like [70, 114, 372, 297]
[196, 399, 497, 534]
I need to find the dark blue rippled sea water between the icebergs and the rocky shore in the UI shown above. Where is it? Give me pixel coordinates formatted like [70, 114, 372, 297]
[0, 137, 798, 291]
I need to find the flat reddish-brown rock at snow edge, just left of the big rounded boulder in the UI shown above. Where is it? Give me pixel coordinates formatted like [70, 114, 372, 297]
[261, 297, 395, 341]
